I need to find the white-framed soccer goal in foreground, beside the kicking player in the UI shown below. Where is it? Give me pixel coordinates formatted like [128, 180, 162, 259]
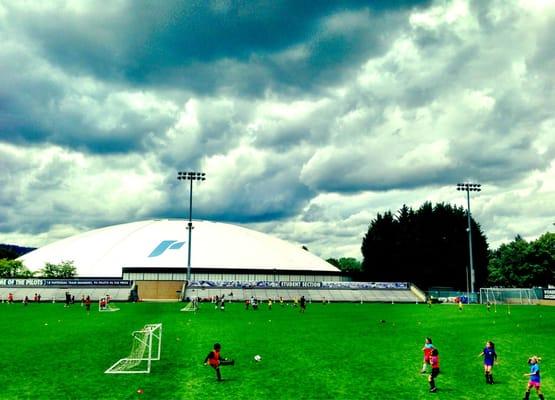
[104, 324, 162, 374]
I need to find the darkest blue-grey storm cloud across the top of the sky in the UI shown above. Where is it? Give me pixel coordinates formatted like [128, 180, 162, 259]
[7, 0, 428, 89]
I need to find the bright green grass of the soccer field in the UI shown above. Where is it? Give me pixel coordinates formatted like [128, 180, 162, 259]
[0, 303, 555, 400]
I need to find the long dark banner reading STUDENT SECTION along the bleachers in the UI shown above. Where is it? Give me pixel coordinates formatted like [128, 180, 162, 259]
[189, 280, 409, 290]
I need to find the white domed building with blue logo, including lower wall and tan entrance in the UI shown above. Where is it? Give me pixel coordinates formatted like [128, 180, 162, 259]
[20, 220, 343, 298]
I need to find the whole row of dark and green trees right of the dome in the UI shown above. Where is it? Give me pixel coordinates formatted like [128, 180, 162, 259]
[327, 202, 555, 291]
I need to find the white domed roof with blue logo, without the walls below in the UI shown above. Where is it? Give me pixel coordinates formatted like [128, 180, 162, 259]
[20, 220, 339, 277]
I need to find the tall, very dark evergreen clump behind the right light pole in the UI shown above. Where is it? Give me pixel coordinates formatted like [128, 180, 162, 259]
[361, 202, 488, 290]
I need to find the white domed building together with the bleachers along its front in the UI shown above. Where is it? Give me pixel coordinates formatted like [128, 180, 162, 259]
[0, 219, 424, 301]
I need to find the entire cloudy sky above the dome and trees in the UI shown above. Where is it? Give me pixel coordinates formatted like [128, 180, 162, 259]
[0, 0, 555, 259]
